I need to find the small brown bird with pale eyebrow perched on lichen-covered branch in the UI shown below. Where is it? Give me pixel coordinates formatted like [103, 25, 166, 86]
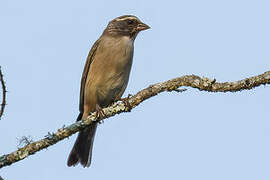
[67, 15, 150, 167]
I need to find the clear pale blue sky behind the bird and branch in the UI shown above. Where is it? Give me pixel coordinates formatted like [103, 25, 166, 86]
[0, 0, 270, 180]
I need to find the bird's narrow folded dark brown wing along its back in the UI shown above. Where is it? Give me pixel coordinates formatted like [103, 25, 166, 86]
[79, 39, 100, 113]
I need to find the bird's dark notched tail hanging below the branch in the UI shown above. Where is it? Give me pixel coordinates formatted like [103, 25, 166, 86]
[67, 114, 97, 167]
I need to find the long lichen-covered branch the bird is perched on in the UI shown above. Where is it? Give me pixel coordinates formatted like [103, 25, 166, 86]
[0, 71, 270, 168]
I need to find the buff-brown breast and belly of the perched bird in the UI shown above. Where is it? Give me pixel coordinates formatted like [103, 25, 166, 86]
[87, 37, 133, 101]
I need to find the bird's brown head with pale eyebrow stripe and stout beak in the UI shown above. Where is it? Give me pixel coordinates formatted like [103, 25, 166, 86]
[104, 15, 150, 38]
